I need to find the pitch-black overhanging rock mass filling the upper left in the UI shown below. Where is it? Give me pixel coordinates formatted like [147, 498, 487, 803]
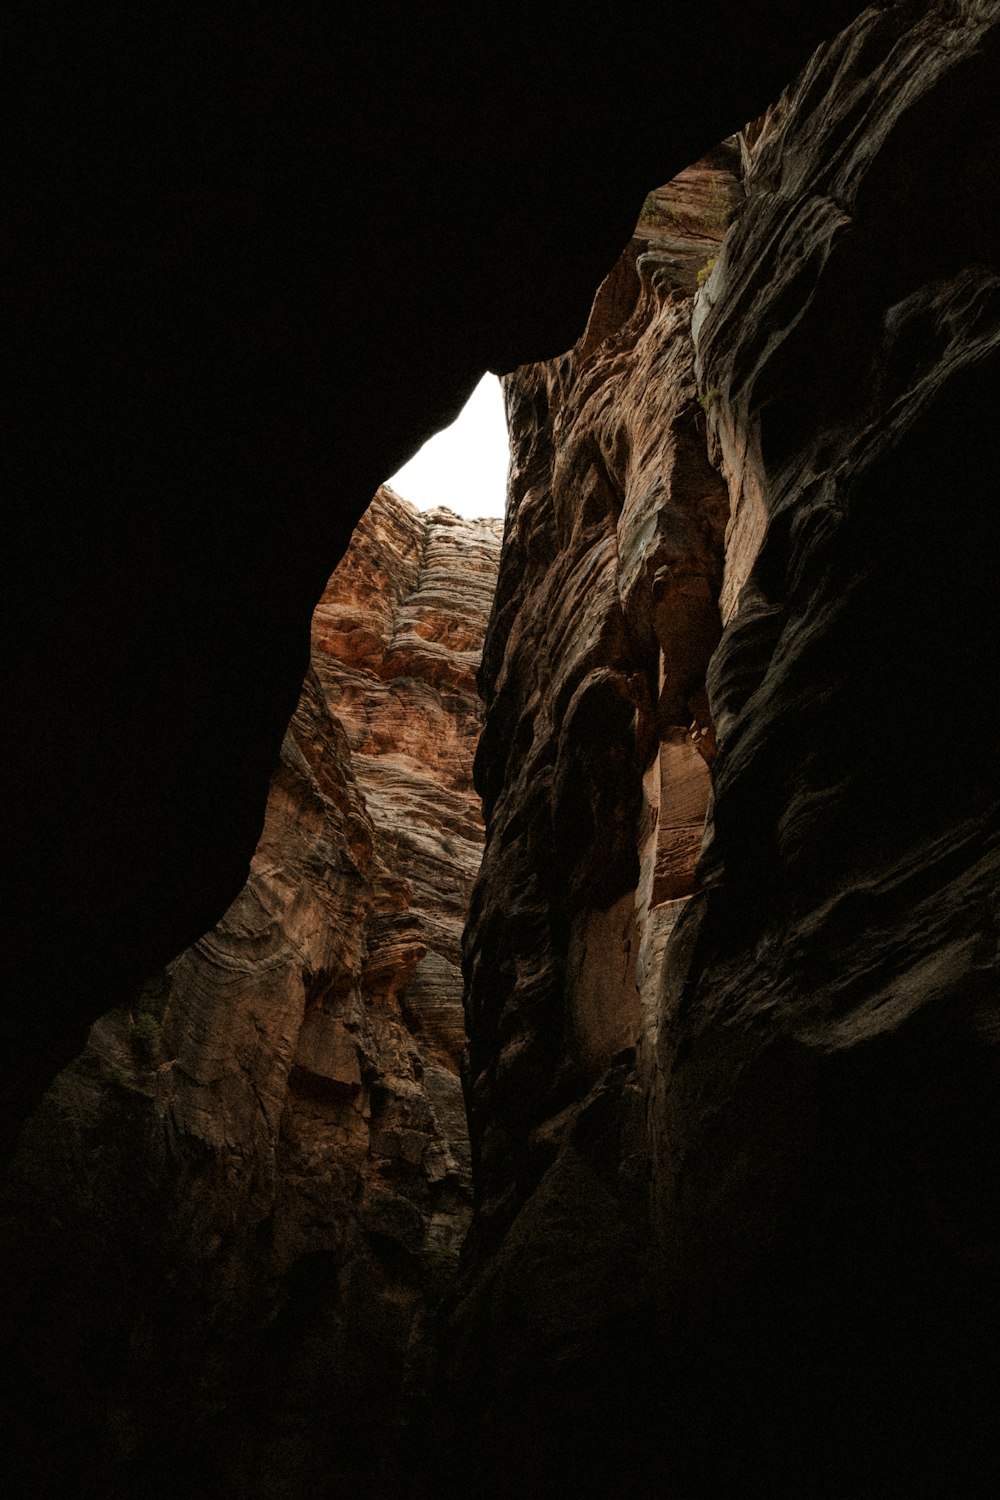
[0, 0, 856, 1151]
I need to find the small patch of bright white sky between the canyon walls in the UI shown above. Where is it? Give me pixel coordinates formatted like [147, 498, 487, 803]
[387, 375, 508, 518]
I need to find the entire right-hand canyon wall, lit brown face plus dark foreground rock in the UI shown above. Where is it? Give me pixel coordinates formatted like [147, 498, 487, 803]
[448, 0, 1000, 1500]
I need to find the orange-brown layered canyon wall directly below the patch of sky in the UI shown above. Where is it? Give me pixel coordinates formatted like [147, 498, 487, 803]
[3, 489, 501, 1497]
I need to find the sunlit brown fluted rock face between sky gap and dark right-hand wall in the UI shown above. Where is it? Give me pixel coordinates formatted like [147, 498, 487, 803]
[466, 149, 739, 1235]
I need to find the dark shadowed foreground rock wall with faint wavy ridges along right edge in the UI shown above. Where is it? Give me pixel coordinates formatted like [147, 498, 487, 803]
[651, 3, 1000, 1496]
